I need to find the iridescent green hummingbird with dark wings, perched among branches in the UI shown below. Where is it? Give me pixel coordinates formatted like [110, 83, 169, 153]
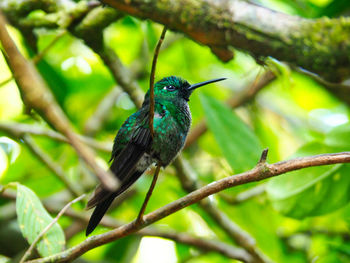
[86, 76, 226, 236]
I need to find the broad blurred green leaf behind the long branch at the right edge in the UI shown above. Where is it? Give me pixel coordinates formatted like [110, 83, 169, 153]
[266, 142, 350, 218]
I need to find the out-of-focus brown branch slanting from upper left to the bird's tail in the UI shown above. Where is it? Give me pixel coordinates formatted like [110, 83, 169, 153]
[0, 11, 119, 190]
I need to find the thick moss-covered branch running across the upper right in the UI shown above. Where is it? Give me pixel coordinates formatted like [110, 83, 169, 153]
[102, 0, 350, 80]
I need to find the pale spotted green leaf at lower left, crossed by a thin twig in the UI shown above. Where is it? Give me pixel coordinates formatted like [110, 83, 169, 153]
[16, 184, 65, 257]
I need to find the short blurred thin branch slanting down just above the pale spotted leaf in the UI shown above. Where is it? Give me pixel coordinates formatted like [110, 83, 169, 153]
[22, 135, 82, 196]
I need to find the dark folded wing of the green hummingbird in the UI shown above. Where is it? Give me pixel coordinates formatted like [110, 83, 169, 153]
[87, 114, 152, 209]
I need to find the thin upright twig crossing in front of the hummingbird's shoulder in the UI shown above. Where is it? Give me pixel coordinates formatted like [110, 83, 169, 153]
[149, 27, 167, 138]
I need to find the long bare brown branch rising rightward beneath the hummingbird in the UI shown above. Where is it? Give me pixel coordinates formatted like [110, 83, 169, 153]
[30, 152, 350, 263]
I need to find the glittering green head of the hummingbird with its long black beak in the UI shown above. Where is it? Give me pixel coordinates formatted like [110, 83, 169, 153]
[146, 76, 226, 101]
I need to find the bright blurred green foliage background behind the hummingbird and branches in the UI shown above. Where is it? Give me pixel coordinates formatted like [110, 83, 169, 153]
[0, 0, 350, 263]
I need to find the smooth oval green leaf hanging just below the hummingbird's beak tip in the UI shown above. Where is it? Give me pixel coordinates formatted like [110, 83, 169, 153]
[201, 96, 261, 173]
